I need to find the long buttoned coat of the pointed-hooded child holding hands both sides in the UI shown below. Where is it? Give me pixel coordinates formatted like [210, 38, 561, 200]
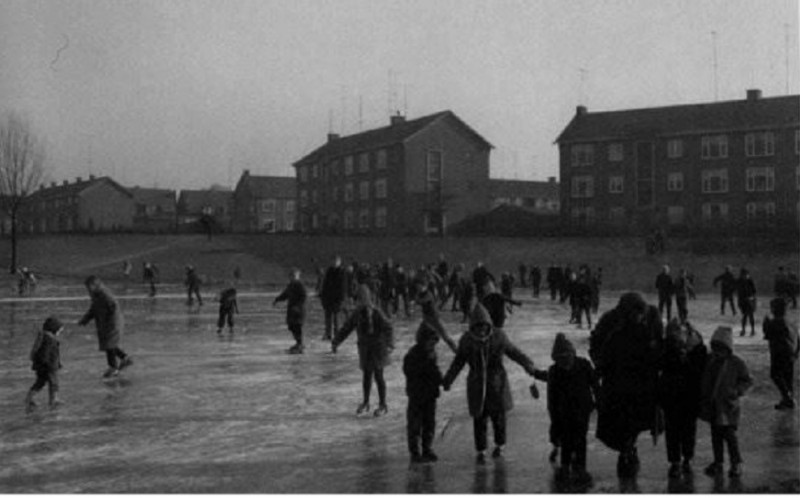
[443, 328, 534, 417]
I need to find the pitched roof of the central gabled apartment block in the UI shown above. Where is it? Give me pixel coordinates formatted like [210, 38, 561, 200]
[294, 111, 492, 166]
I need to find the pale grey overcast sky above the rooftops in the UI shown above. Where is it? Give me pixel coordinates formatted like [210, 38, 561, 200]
[0, 0, 800, 189]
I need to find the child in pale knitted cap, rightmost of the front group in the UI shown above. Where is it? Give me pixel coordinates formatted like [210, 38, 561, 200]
[700, 327, 753, 477]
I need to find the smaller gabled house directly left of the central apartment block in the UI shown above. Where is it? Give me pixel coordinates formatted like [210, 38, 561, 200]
[233, 170, 297, 233]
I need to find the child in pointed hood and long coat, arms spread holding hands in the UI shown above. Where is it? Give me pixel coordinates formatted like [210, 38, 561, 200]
[442, 304, 535, 463]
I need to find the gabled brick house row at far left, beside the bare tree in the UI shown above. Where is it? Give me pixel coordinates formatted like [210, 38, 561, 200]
[19, 175, 134, 233]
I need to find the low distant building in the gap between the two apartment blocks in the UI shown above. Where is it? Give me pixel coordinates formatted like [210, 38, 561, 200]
[489, 177, 560, 215]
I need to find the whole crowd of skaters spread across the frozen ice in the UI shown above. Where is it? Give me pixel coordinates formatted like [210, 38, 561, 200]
[18, 251, 800, 488]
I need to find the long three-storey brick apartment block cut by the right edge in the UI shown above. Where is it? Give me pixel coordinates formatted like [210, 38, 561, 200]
[556, 90, 800, 230]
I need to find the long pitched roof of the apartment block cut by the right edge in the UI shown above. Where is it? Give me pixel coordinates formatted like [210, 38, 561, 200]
[556, 95, 800, 143]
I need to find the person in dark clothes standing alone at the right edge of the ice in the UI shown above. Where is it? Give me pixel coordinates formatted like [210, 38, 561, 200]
[762, 298, 800, 410]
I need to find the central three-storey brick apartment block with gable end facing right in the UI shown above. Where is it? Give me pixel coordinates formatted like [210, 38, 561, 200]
[294, 111, 492, 235]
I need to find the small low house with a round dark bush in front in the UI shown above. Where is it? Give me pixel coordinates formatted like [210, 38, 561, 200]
[178, 189, 233, 232]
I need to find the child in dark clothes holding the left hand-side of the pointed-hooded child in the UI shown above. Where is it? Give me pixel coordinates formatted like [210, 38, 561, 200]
[403, 322, 442, 463]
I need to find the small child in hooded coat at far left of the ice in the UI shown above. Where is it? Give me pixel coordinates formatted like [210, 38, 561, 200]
[25, 316, 64, 410]
